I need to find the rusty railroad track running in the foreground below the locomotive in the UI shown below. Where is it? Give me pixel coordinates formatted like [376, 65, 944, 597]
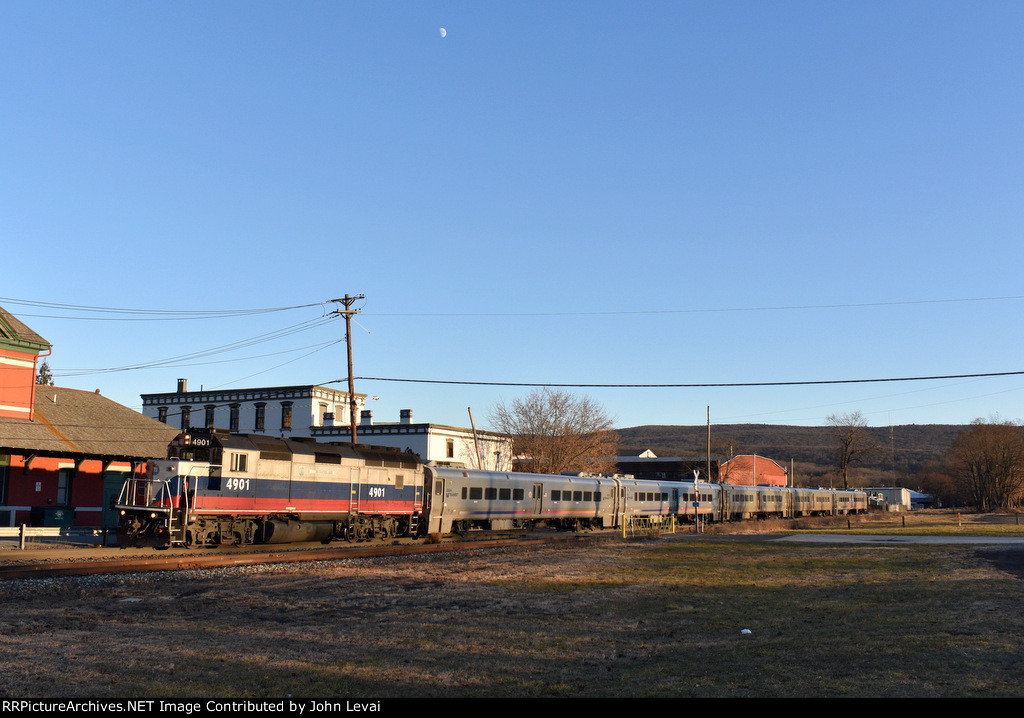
[0, 535, 590, 580]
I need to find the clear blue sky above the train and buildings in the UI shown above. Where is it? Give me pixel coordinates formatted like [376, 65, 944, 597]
[0, 0, 1024, 426]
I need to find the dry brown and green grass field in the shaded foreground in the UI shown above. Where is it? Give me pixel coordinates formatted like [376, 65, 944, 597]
[0, 518, 1024, 700]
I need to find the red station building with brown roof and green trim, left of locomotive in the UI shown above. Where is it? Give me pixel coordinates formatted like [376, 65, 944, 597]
[0, 307, 177, 526]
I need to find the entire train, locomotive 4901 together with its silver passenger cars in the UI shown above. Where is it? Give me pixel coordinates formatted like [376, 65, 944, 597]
[117, 429, 867, 548]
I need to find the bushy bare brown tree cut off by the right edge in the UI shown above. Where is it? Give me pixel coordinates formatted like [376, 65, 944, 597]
[947, 419, 1024, 511]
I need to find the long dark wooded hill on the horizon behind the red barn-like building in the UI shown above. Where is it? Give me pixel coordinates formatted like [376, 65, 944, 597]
[616, 424, 968, 485]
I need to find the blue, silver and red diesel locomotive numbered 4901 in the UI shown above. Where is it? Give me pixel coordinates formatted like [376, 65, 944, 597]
[117, 429, 424, 546]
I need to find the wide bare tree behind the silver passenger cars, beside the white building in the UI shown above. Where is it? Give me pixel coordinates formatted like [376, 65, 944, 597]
[489, 387, 616, 473]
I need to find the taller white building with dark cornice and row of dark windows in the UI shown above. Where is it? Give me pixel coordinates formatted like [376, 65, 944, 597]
[142, 379, 367, 436]
